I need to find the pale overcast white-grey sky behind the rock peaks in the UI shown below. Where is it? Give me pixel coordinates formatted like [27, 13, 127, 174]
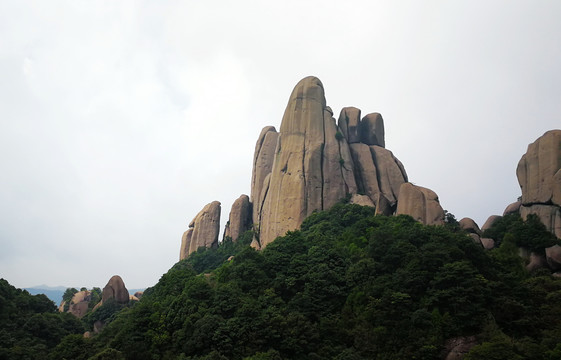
[0, 0, 561, 288]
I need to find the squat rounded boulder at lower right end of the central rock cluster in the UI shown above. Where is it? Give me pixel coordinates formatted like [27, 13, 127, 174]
[396, 183, 444, 225]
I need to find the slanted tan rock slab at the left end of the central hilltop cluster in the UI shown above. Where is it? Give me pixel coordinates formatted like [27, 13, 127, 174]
[179, 201, 220, 260]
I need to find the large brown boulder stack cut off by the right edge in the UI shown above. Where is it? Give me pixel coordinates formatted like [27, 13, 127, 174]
[516, 130, 561, 239]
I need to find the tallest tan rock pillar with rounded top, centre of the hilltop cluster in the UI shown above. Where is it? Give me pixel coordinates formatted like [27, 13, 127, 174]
[257, 77, 356, 246]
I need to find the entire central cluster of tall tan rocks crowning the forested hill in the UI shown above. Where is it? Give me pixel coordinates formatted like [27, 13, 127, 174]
[180, 76, 444, 259]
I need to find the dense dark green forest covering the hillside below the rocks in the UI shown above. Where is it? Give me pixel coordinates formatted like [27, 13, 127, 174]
[0, 204, 561, 360]
